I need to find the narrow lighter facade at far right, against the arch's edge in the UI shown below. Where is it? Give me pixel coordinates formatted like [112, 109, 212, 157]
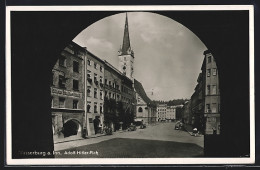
[202, 50, 220, 134]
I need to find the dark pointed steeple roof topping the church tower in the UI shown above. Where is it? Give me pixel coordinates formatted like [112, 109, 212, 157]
[121, 13, 132, 55]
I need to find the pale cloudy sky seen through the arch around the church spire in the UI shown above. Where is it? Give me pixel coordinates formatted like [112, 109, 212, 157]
[73, 12, 207, 101]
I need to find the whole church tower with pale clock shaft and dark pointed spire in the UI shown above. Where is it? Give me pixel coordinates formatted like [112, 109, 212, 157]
[118, 13, 134, 81]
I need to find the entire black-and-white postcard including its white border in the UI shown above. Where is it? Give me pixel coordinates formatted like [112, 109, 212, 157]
[6, 5, 255, 165]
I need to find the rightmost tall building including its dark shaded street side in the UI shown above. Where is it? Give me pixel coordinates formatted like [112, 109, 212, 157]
[190, 50, 220, 135]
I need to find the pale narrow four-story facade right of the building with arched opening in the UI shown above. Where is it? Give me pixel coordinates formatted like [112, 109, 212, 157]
[86, 51, 105, 135]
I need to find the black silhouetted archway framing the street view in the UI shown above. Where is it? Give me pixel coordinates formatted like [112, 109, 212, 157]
[11, 11, 250, 158]
